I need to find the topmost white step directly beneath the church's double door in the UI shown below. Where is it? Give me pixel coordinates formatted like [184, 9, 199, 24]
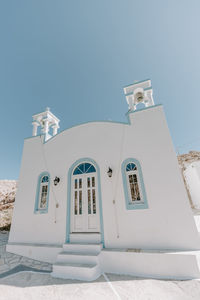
[70, 232, 101, 243]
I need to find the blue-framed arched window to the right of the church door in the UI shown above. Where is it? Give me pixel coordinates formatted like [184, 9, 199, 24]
[122, 158, 148, 209]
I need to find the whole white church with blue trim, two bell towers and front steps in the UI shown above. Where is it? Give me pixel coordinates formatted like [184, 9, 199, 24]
[7, 80, 200, 281]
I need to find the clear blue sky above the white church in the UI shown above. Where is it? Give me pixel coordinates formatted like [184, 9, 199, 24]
[0, 0, 200, 179]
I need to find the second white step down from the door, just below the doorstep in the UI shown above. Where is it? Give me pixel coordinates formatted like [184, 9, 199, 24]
[63, 243, 102, 254]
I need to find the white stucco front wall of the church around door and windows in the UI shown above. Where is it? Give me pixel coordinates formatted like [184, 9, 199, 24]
[9, 106, 200, 249]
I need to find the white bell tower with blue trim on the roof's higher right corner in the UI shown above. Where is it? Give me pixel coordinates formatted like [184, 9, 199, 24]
[124, 79, 154, 111]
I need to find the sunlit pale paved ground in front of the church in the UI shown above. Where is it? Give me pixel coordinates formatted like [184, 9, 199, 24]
[0, 272, 200, 300]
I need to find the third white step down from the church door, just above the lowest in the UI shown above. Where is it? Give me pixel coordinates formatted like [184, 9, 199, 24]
[56, 252, 98, 264]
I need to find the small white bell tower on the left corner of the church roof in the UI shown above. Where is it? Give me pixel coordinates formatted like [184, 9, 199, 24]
[32, 107, 60, 141]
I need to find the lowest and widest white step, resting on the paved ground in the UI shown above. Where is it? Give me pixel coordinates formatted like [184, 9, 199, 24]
[51, 263, 101, 281]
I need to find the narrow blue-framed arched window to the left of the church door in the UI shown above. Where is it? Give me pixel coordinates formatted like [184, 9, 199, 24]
[34, 172, 50, 213]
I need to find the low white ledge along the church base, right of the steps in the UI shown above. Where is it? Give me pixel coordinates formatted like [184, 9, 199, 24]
[100, 250, 200, 280]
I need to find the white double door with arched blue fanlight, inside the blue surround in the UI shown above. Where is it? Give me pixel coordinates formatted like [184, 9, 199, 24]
[70, 161, 100, 233]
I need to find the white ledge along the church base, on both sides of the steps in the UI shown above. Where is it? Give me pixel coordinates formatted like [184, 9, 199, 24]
[6, 244, 200, 280]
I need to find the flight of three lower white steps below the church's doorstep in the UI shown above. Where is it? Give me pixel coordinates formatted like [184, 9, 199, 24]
[51, 234, 102, 281]
